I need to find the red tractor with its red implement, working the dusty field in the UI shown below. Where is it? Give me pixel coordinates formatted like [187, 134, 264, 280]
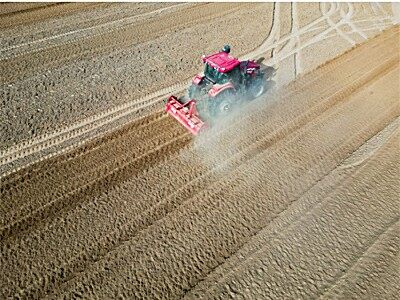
[166, 46, 275, 135]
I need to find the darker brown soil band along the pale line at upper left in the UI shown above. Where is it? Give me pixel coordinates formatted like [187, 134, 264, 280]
[0, 3, 250, 83]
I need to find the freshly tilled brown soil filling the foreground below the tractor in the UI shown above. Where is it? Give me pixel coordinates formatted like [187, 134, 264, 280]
[1, 23, 400, 298]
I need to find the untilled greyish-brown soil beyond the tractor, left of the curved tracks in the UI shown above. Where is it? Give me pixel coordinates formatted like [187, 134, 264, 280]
[0, 3, 273, 150]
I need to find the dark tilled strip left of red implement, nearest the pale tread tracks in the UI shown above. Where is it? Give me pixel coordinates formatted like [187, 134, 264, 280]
[1, 115, 173, 225]
